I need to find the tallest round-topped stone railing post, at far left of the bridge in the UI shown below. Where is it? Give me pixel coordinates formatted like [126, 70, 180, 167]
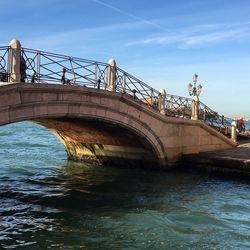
[9, 39, 21, 83]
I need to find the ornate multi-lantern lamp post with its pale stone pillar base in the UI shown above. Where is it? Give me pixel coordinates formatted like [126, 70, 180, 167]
[188, 74, 202, 120]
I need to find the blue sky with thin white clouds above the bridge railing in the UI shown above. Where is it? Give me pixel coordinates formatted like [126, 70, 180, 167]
[0, 0, 250, 118]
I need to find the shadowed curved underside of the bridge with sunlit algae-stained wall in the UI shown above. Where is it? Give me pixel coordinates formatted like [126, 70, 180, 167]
[34, 118, 160, 169]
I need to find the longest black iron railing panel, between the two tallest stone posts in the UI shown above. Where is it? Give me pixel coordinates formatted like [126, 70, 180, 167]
[21, 49, 108, 88]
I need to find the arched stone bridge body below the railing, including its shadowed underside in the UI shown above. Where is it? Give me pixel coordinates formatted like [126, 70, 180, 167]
[0, 82, 236, 168]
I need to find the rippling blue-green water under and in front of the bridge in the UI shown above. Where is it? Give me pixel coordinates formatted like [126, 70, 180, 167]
[0, 122, 250, 249]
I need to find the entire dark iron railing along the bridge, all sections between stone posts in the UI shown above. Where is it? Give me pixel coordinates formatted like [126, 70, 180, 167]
[0, 46, 231, 132]
